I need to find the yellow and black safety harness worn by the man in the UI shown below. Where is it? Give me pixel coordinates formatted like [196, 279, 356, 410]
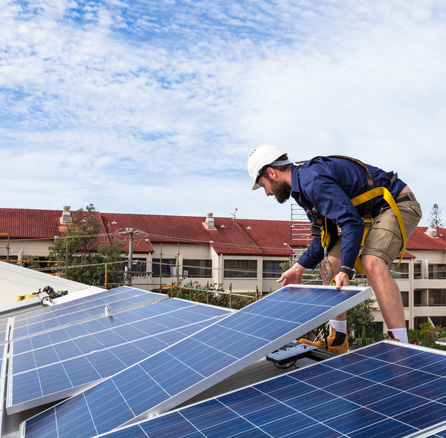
[299, 155, 407, 278]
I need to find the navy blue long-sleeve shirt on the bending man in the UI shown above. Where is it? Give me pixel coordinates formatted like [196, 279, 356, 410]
[291, 157, 406, 269]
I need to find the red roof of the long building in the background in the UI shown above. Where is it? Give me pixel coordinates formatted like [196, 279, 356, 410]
[0, 208, 446, 258]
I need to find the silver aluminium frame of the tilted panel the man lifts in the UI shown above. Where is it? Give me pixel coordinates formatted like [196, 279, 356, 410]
[21, 284, 373, 437]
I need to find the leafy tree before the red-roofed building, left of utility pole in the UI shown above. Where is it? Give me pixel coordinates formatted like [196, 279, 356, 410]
[49, 204, 126, 286]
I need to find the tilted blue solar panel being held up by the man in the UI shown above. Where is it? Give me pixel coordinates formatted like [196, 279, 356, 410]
[23, 285, 372, 438]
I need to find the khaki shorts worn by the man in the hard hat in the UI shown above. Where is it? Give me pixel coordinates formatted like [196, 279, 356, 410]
[329, 197, 422, 267]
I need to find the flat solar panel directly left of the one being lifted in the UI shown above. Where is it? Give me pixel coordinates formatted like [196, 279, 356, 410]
[7, 298, 232, 414]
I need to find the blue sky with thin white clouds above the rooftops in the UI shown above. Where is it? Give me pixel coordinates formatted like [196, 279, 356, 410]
[0, 0, 446, 226]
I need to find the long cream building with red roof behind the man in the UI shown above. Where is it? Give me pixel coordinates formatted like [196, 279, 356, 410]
[0, 207, 446, 331]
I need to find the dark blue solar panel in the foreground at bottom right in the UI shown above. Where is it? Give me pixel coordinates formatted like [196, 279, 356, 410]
[95, 341, 446, 438]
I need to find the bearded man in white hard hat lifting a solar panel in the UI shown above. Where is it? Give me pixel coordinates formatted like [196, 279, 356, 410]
[248, 145, 422, 354]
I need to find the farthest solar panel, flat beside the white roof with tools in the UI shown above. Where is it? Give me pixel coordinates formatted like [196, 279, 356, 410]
[11, 286, 168, 339]
